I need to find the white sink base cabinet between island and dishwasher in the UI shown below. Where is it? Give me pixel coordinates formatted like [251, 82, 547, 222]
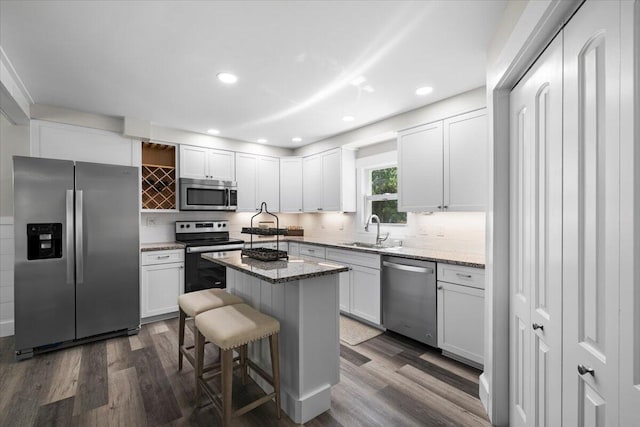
[326, 248, 382, 325]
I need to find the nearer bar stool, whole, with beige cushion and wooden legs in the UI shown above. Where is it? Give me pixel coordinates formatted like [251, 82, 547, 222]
[195, 304, 280, 426]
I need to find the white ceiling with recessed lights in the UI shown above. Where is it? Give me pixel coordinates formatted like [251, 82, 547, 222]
[0, 0, 505, 148]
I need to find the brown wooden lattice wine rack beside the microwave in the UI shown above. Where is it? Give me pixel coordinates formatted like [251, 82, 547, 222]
[142, 142, 176, 210]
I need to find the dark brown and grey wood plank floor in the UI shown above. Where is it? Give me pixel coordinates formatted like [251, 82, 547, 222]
[0, 319, 490, 426]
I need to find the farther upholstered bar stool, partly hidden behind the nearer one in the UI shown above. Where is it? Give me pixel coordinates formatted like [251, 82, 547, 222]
[178, 289, 244, 372]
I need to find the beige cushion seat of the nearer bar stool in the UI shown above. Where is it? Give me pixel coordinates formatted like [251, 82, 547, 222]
[196, 304, 280, 350]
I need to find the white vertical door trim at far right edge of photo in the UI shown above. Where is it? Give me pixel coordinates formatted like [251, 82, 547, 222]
[619, 0, 640, 426]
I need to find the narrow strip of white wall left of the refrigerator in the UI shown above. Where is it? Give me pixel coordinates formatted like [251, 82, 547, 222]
[0, 114, 29, 337]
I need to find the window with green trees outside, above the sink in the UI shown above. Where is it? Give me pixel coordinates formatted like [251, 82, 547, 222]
[366, 166, 407, 224]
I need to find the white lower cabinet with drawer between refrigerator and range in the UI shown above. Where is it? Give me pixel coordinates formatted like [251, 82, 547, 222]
[140, 250, 184, 319]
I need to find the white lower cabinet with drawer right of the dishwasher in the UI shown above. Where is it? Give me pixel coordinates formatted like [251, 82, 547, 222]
[437, 263, 484, 365]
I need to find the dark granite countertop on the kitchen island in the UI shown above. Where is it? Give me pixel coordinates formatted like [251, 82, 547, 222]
[202, 251, 349, 283]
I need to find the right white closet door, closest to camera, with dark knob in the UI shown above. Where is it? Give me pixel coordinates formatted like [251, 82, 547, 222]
[563, 1, 620, 426]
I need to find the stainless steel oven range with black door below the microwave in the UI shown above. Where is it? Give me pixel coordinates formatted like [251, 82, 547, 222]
[176, 221, 244, 292]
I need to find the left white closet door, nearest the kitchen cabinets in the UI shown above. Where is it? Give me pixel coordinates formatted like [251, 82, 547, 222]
[509, 35, 562, 426]
